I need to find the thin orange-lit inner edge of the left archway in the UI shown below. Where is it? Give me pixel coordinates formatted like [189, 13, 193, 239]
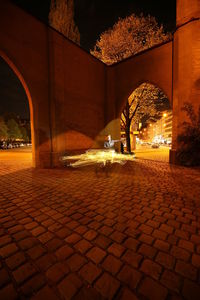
[0, 50, 36, 167]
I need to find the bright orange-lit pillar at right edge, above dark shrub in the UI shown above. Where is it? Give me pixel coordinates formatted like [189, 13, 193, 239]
[170, 0, 200, 162]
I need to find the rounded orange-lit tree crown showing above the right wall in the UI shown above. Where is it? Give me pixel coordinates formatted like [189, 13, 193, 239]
[90, 14, 171, 65]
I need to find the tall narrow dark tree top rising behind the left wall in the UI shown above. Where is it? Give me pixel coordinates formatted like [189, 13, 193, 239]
[49, 0, 80, 45]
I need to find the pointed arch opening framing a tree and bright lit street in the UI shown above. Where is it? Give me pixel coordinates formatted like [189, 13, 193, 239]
[120, 82, 173, 161]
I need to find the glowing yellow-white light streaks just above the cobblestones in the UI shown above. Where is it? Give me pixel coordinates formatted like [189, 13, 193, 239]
[62, 149, 135, 168]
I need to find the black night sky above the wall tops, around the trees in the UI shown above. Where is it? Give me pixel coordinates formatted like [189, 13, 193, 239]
[12, 0, 176, 51]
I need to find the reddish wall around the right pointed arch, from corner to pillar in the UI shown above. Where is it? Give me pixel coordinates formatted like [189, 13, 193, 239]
[106, 41, 173, 158]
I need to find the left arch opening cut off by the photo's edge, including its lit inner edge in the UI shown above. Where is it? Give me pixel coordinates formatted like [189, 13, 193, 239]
[0, 51, 35, 167]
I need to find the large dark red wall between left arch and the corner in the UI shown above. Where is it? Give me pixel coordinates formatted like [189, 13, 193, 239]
[0, 1, 106, 167]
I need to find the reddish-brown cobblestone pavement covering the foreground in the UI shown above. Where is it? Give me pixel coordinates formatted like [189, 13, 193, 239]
[0, 152, 200, 300]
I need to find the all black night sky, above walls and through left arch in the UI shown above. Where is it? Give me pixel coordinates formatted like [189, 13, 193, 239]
[0, 0, 176, 118]
